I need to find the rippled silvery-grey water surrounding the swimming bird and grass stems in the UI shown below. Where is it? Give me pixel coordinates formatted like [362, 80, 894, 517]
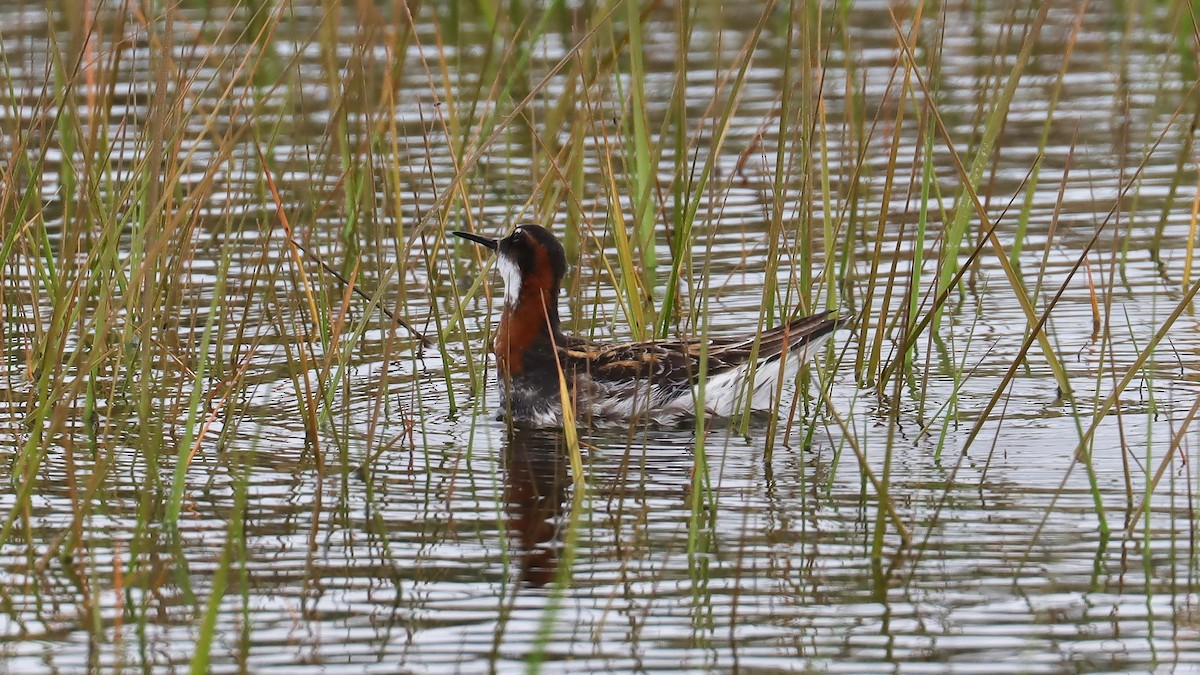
[0, 4, 1200, 673]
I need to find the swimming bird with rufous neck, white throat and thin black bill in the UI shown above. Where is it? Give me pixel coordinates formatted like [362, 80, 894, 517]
[452, 225, 851, 428]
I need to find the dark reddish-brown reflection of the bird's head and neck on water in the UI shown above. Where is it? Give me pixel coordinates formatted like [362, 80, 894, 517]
[504, 429, 570, 587]
